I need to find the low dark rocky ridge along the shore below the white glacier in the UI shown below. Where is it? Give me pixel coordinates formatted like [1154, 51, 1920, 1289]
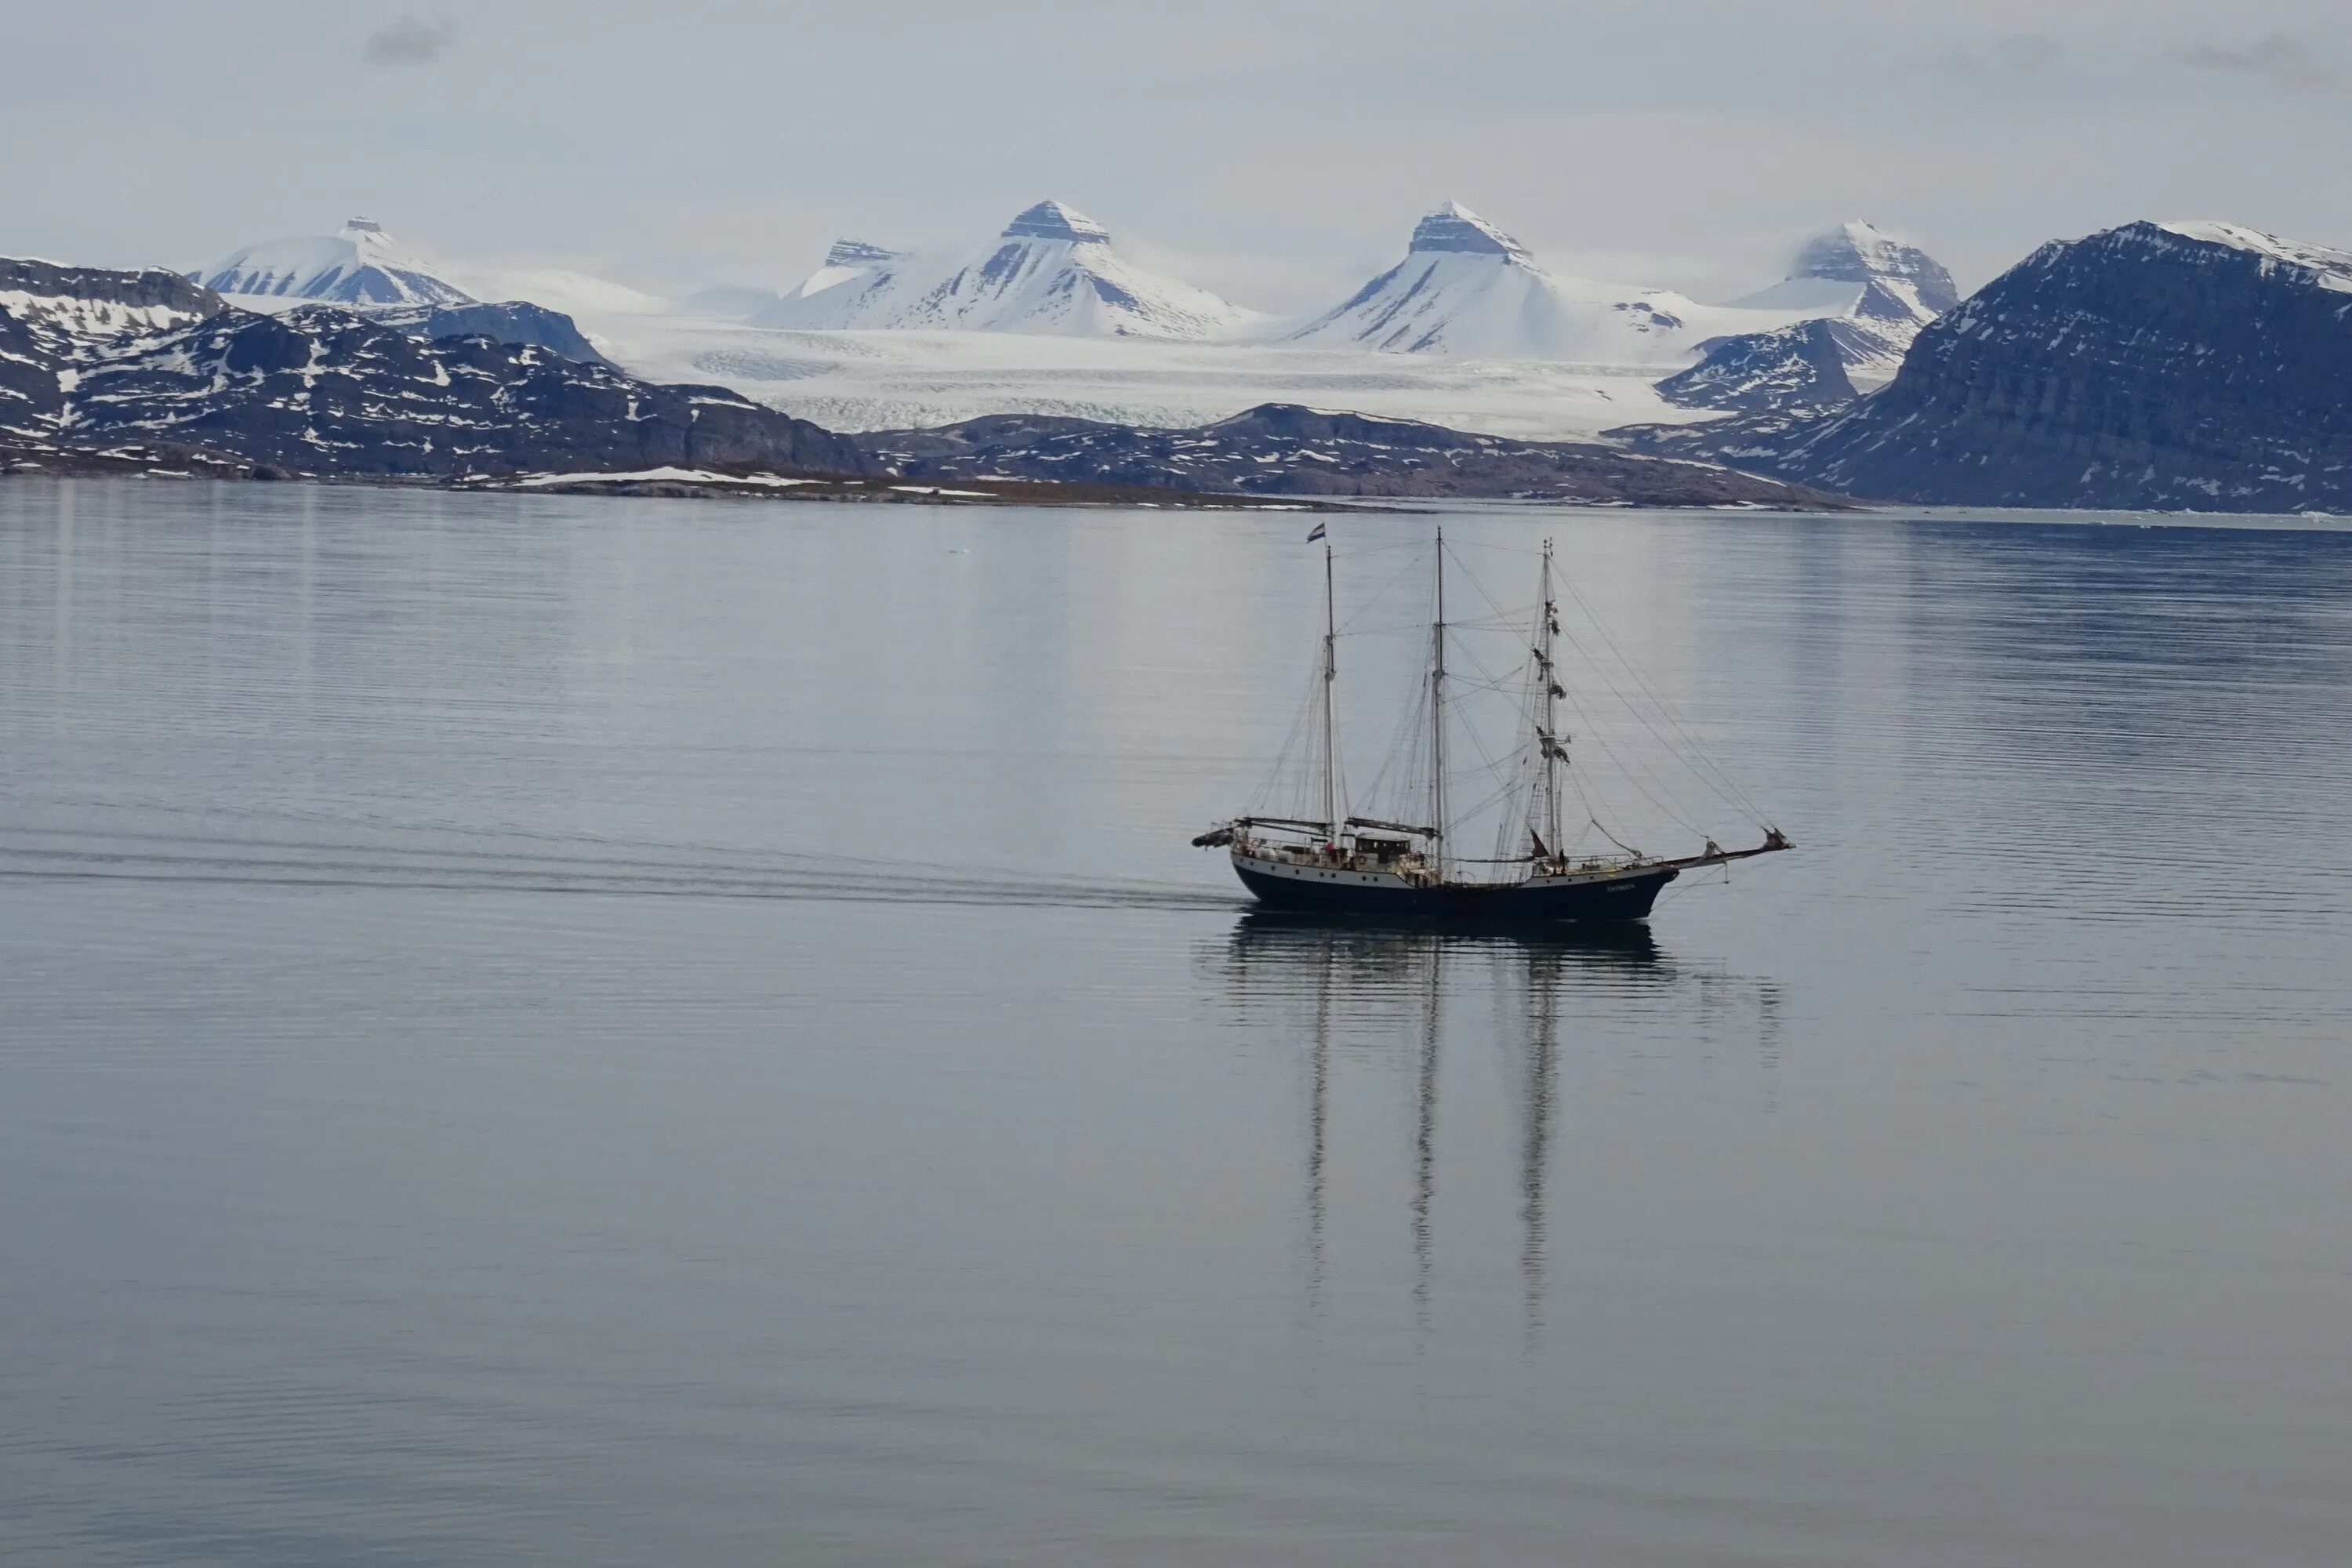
[856, 405, 1837, 508]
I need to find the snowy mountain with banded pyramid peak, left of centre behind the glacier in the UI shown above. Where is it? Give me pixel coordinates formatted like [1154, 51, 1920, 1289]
[757, 202, 1258, 341]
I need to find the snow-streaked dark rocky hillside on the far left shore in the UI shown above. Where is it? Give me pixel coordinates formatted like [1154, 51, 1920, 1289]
[0, 261, 873, 480]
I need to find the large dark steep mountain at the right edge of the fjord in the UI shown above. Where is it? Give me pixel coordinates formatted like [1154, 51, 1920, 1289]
[1630, 223, 2352, 513]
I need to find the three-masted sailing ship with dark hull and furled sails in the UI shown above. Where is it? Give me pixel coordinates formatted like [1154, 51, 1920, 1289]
[1192, 527, 1790, 924]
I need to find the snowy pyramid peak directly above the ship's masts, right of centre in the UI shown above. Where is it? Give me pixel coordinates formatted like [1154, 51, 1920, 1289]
[1287, 202, 1750, 365]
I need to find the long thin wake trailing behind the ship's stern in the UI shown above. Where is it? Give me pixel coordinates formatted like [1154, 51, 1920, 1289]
[0, 806, 1242, 909]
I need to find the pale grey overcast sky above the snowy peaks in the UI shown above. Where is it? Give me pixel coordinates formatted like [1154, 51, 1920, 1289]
[0, 0, 2352, 310]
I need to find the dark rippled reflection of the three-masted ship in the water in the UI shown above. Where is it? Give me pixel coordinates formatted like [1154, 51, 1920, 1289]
[1211, 909, 1783, 1354]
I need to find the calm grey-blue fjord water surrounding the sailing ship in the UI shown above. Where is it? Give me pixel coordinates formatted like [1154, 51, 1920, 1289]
[0, 480, 2352, 1568]
